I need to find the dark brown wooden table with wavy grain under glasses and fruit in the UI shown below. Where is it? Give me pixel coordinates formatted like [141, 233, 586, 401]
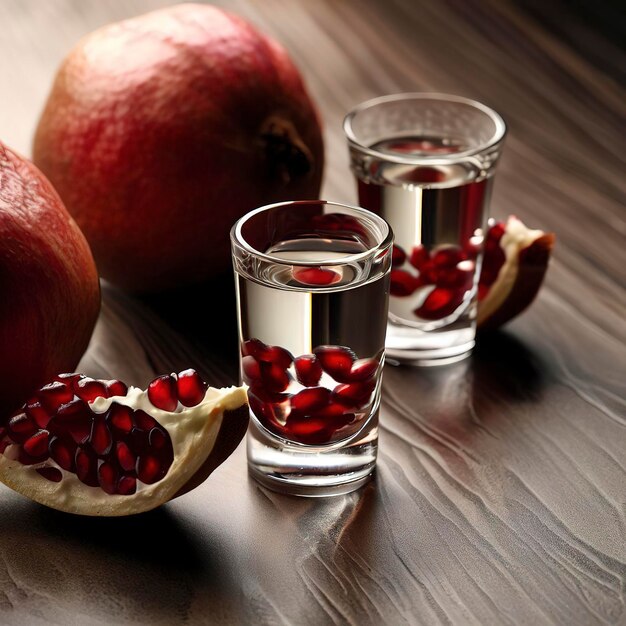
[0, 0, 626, 625]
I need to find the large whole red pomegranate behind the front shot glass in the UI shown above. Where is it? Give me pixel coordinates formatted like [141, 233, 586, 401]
[34, 4, 323, 292]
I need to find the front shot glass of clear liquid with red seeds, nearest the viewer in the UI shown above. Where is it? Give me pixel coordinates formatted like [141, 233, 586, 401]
[231, 200, 393, 496]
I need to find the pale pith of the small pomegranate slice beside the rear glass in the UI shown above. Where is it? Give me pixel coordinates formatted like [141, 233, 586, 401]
[476, 216, 545, 326]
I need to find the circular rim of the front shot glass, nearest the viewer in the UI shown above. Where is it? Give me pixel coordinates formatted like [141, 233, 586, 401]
[230, 200, 393, 267]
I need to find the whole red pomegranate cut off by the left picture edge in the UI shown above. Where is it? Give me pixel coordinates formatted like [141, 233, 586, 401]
[0, 142, 100, 417]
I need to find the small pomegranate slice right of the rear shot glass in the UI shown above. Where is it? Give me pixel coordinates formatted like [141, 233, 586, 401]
[477, 216, 556, 330]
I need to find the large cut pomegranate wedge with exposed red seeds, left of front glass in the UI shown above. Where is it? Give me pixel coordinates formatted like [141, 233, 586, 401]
[0, 370, 248, 516]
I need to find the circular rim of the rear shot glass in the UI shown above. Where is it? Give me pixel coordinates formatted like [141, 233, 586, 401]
[343, 92, 507, 165]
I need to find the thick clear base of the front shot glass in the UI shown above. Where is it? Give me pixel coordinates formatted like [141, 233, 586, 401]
[247, 411, 378, 498]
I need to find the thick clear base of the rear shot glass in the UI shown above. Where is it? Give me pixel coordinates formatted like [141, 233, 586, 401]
[385, 321, 476, 366]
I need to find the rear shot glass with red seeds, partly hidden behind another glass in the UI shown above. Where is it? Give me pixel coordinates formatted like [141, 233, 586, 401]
[344, 93, 506, 365]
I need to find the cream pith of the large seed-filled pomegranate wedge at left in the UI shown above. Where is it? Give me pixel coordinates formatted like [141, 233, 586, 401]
[0, 387, 247, 516]
